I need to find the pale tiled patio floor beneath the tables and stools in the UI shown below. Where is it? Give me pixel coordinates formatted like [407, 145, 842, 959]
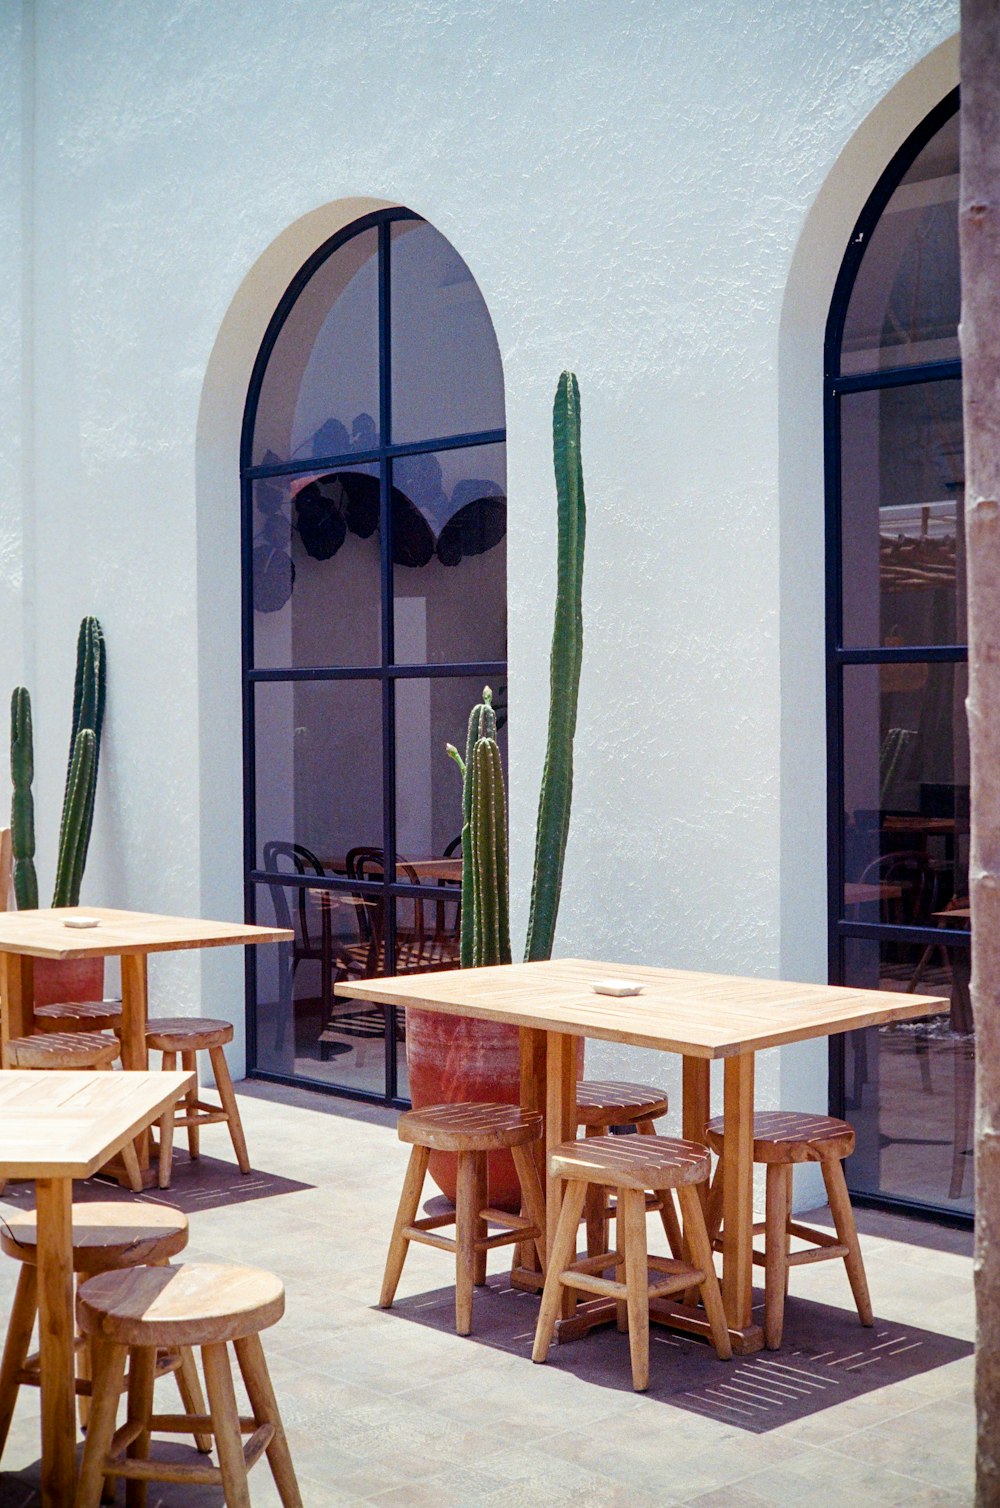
[0, 1083, 974, 1508]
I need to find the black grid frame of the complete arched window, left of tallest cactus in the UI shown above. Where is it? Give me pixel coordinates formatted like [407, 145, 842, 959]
[240, 207, 507, 1108]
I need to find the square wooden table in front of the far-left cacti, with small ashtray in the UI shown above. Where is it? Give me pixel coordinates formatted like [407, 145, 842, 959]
[0, 906, 294, 1184]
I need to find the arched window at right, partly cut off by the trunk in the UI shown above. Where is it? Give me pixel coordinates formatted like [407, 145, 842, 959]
[825, 92, 974, 1214]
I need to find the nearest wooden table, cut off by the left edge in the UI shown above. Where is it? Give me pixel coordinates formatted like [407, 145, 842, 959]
[0, 1069, 195, 1508]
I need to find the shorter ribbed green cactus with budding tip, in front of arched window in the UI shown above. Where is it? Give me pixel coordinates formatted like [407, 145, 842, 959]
[448, 686, 511, 968]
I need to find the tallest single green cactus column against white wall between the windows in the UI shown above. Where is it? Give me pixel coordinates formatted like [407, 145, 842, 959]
[525, 372, 587, 962]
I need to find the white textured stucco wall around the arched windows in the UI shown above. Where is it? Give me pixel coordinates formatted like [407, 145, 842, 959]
[0, 0, 958, 1176]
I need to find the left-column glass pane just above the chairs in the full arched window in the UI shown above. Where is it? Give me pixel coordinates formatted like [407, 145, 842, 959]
[255, 680, 382, 875]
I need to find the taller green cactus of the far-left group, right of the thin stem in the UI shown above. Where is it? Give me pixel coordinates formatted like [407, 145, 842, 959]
[53, 618, 107, 906]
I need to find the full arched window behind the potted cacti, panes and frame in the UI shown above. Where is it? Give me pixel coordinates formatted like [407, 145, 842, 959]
[241, 210, 507, 1101]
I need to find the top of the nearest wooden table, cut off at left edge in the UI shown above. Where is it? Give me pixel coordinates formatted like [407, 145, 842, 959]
[0, 1068, 195, 1179]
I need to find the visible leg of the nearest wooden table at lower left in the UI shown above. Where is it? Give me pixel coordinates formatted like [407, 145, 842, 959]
[36, 1178, 77, 1508]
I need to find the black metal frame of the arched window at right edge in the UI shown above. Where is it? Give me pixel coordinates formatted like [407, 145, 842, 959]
[824, 89, 973, 1228]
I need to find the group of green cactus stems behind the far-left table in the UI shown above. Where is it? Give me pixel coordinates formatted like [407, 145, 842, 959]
[11, 618, 107, 911]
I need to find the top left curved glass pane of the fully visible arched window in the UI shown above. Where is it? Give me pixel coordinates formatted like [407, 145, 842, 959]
[253, 229, 379, 466]
